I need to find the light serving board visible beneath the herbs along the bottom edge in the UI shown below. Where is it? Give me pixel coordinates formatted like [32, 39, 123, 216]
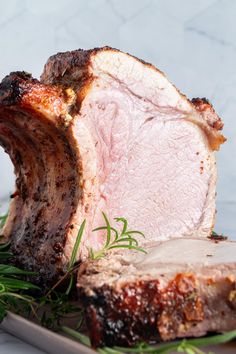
[0, 312, 236, 354]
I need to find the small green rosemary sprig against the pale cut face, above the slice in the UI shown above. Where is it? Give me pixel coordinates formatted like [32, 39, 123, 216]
[89, 213, 147, 260]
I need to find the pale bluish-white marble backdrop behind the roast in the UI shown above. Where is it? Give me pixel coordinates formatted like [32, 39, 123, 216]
[0, 0, 236, 353]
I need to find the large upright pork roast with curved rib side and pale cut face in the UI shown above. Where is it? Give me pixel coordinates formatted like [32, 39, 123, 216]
[0, 47, 225, 281]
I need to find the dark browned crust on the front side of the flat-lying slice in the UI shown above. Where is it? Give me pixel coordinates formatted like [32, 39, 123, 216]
[78, 273, 236, 347]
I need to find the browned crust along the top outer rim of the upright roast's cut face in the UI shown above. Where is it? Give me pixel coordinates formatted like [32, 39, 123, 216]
[41, 46, 226, 142]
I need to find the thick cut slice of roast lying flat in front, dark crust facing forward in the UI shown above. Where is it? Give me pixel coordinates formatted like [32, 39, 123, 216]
[77, 238, 236, 347]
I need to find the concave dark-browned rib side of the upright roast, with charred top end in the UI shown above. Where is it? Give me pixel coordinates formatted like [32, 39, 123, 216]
[0, 74, 82, 284]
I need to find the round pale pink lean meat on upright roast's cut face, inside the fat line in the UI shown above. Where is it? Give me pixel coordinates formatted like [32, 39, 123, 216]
[75, 82, 214, 253]
